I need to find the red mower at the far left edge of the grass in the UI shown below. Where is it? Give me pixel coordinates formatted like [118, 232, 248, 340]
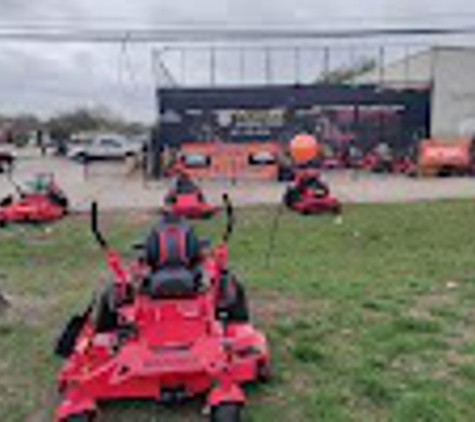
[0, 174, 69, 226]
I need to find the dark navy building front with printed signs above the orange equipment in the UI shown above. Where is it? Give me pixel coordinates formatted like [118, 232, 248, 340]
[152, 84, 431, 176]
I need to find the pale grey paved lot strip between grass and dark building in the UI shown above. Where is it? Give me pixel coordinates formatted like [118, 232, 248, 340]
[0, 151, 475, 211]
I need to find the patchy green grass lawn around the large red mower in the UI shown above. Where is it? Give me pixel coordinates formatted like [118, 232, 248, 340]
[0, 201, 475, 422]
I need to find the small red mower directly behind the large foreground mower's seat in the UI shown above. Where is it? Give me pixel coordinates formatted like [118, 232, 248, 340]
[165, 174, 219, 219]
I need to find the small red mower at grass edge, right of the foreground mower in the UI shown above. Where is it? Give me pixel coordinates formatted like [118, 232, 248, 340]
[283, 170, 341, 214]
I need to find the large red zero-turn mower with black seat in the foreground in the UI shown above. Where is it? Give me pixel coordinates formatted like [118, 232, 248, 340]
[55, 197, 270, 422]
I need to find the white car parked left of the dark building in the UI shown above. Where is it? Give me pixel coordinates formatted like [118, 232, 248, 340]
[68, 135, 142, 162]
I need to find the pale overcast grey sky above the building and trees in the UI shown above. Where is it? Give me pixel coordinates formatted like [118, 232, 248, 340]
[0, 0, 475, 121]
